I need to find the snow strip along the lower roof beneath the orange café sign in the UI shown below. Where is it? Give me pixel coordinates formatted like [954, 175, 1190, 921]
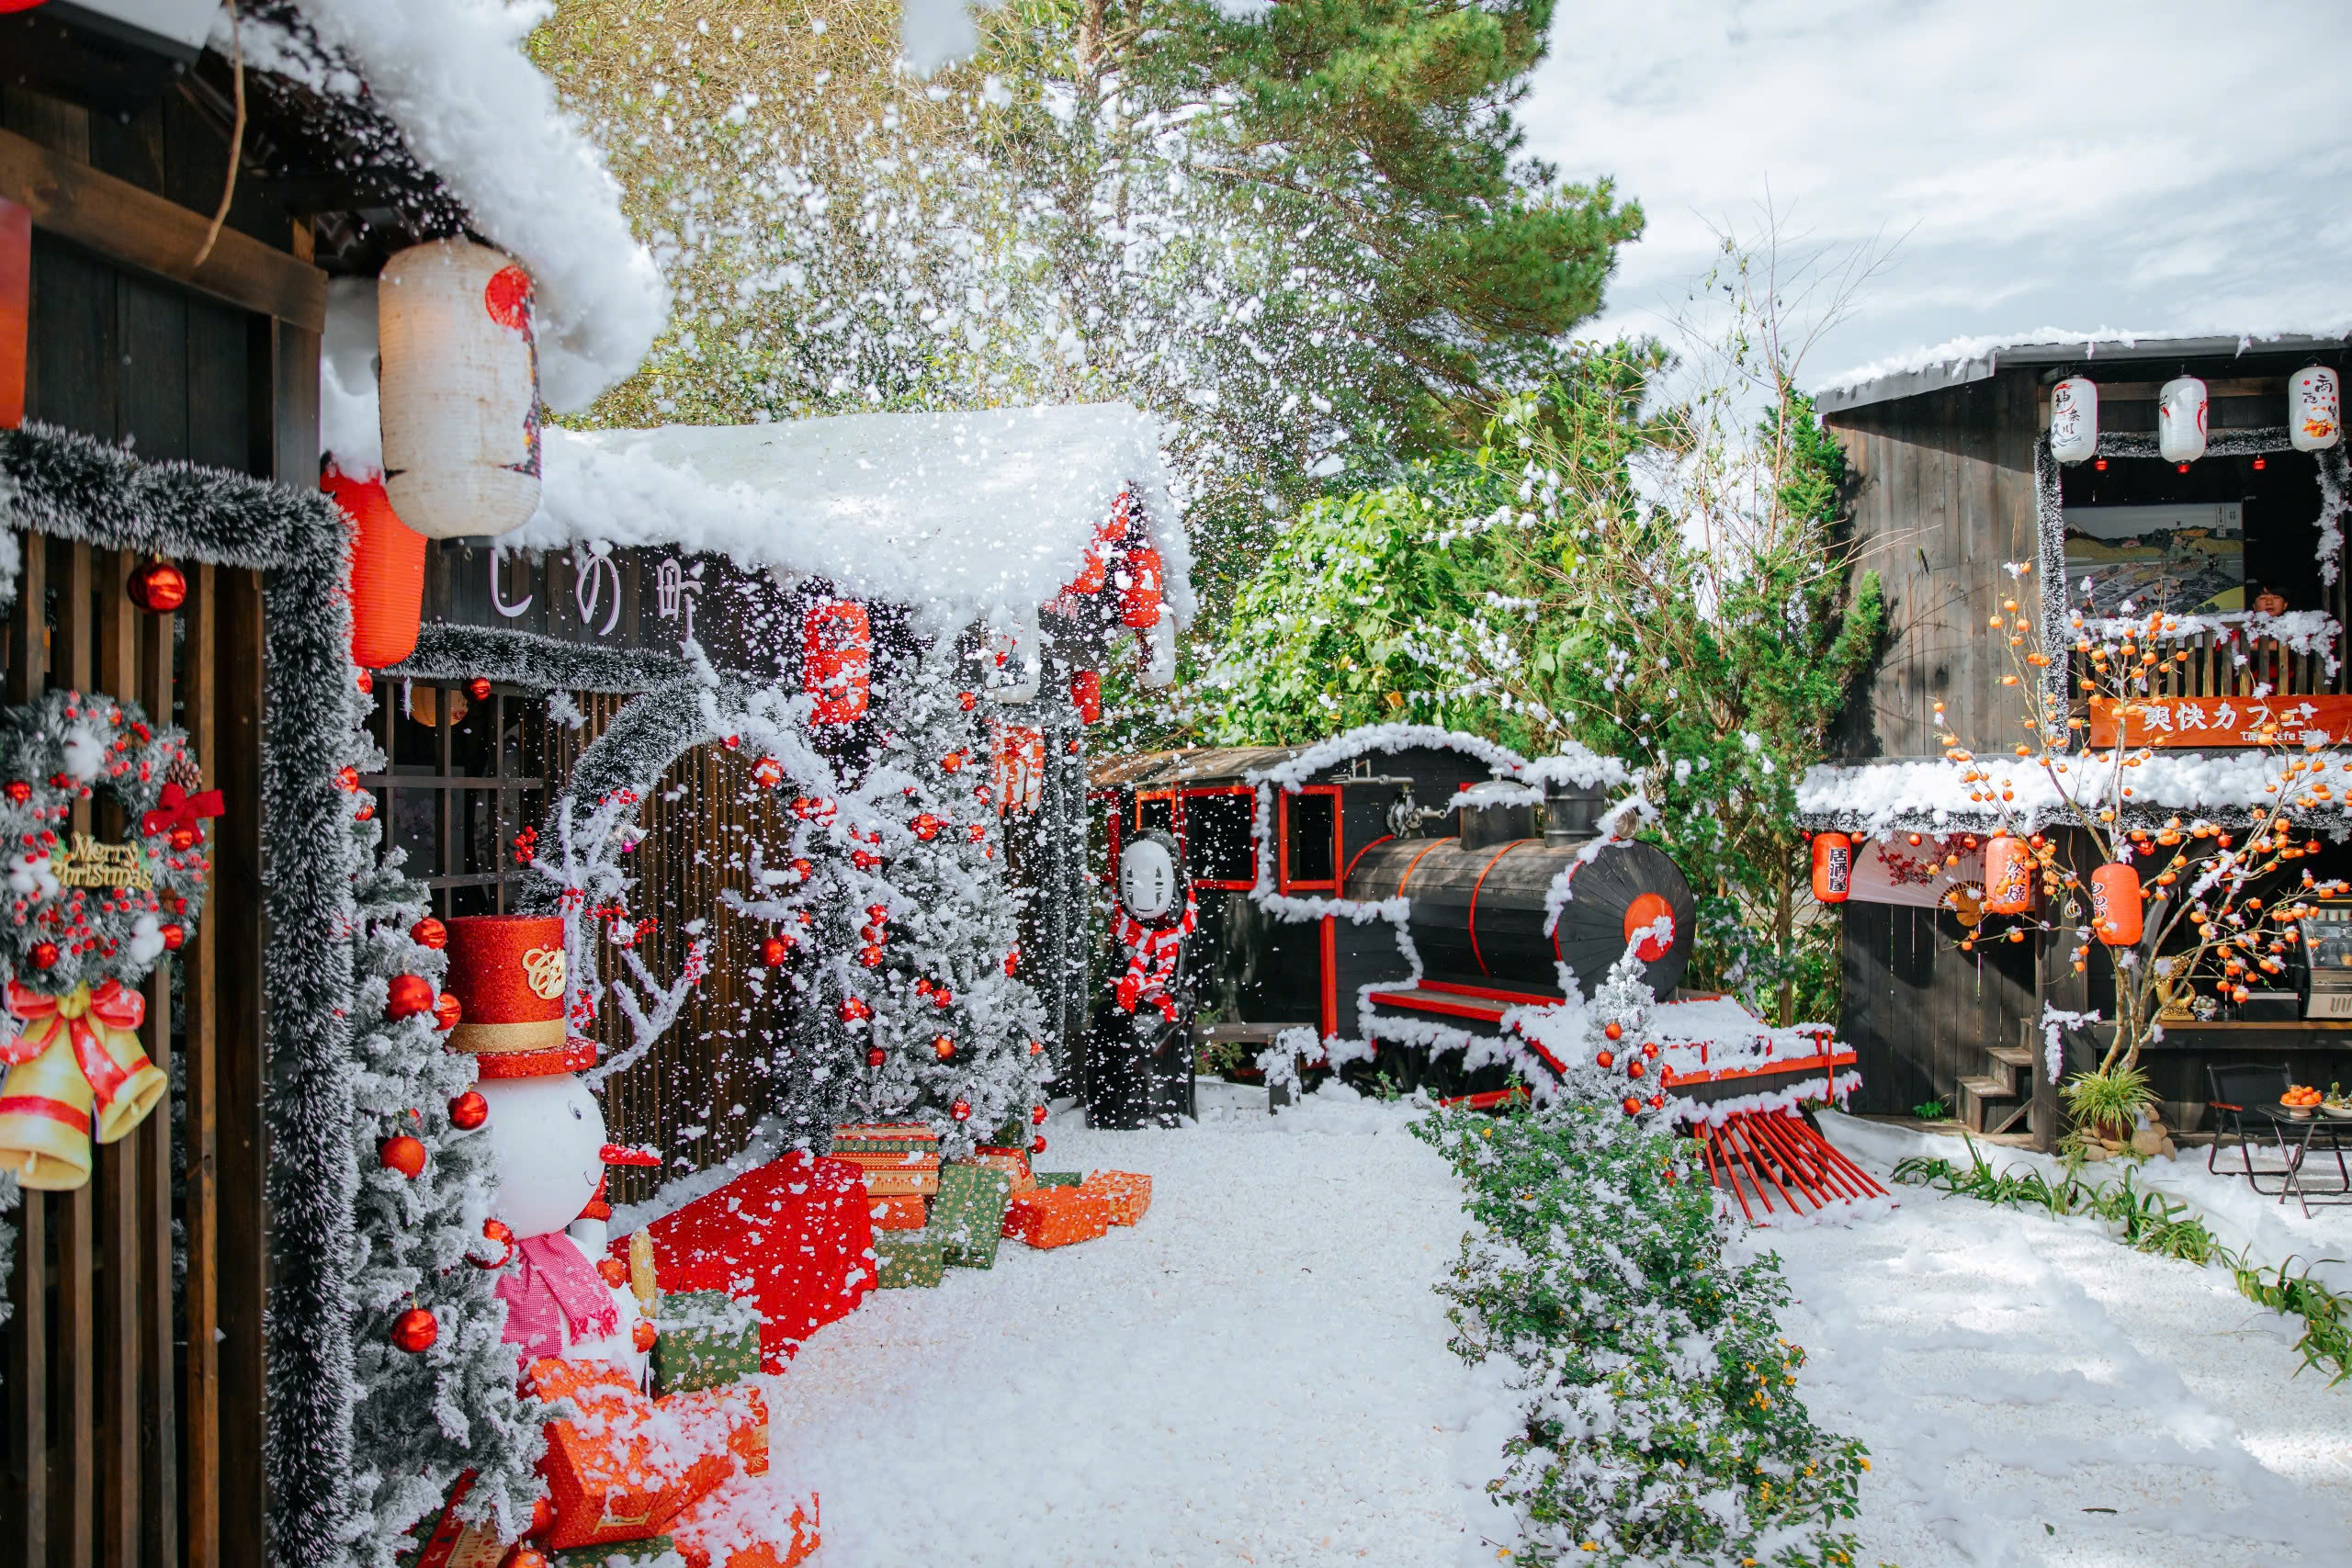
[1797, 750, 2352, 835]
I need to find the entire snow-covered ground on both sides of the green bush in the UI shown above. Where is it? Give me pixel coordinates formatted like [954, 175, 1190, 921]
[715, 1084, 2352, 1568]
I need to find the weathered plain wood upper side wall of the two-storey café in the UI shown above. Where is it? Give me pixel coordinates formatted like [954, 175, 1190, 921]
[1827, 371, 2040, 757]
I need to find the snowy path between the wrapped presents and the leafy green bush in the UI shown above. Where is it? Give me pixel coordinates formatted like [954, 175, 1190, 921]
[767, 1081, 1510, 1568]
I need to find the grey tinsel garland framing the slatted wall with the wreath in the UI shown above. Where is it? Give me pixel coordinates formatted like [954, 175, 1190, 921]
[0, 423, 501, 1568]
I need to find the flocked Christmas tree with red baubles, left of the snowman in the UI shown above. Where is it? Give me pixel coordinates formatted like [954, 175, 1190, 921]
[341, 728, 543, 1568]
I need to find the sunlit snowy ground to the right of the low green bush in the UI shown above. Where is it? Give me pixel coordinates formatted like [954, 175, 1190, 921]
[1769, 1117, 2352, 1568]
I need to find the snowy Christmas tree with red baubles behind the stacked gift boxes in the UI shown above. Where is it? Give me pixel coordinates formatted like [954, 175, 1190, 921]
[847, 659, 1045, 1156]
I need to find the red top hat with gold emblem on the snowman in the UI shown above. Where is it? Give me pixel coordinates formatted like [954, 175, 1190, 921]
[449, 915, 595, 1079]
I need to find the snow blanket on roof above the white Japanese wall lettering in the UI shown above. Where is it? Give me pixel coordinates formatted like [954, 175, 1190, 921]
[503, 402, 1193, 630]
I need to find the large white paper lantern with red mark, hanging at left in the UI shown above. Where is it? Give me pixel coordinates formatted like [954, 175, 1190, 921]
[377, 240, 538, 538]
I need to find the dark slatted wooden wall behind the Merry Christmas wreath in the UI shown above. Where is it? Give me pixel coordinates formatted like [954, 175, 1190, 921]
[0, 87, 324, 1568]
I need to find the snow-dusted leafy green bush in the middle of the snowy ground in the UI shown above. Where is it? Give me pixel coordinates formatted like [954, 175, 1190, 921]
[1416, 1105, 1870, 1568]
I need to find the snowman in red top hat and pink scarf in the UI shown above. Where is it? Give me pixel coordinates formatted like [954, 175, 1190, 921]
[449, 915, 651, 1384]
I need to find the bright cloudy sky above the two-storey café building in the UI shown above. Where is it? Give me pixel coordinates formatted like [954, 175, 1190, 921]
[1521, 0, 2352, 383]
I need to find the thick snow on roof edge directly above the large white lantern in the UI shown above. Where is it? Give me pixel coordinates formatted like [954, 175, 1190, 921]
[288, 0, 671, 412]
